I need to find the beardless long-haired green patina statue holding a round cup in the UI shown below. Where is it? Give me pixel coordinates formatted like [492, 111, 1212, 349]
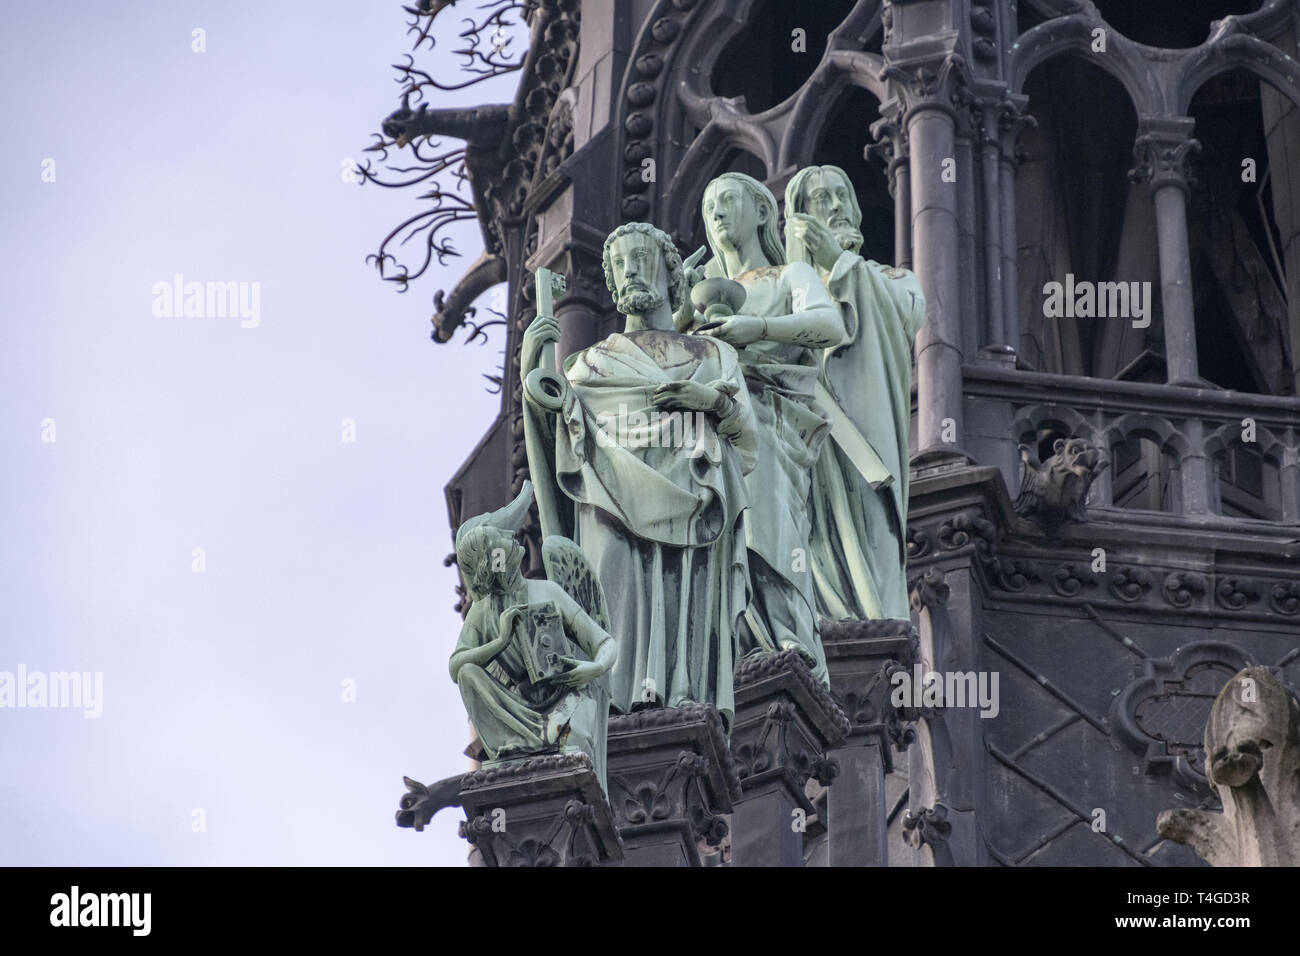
[677, 173, 844, 683]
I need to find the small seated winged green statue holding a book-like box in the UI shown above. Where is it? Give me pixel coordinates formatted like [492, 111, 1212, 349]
[451, 481, 618, 787]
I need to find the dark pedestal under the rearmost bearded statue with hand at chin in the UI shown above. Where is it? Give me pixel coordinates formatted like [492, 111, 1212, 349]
[822, 620, 917, 866]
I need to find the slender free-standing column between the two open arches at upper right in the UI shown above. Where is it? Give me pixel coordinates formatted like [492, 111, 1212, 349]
[1130, 116, 1201, 385]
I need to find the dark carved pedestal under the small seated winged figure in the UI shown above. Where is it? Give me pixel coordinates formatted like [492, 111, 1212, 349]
[458, 754, 623, 866]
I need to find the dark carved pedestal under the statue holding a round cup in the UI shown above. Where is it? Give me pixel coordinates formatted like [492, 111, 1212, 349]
[732, 650, 849, 866]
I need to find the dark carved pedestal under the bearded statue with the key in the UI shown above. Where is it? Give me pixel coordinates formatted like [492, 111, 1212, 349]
[607, 704, 740, 866]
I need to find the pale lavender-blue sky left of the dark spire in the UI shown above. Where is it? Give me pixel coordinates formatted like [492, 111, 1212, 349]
[0, 0, 512, 865]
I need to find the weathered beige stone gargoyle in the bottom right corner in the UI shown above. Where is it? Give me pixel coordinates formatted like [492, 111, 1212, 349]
[1156, 667, 1300, 866]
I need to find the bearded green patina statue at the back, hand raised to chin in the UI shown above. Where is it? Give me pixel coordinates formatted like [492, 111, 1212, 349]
[785, 166, 926, 620]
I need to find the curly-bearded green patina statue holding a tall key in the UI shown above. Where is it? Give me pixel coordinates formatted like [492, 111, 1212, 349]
[520, 222, 758, 727]
